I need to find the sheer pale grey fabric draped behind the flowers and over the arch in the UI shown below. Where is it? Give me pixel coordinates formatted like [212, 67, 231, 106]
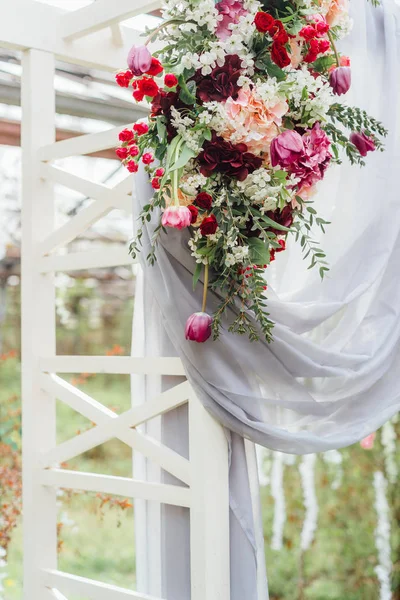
[135, 0, 400, 600]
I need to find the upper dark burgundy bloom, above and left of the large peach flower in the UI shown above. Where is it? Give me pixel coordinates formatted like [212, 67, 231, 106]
[195, 54, 242, 102]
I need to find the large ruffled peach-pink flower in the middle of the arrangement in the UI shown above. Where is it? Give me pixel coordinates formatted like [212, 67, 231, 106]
[221, 88, 288, 155]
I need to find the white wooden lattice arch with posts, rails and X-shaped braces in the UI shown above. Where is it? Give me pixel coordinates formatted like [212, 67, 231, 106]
[0, 0, 230, 600]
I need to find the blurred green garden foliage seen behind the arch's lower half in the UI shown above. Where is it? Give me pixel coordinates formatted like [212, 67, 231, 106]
[0, 282, 400, 600]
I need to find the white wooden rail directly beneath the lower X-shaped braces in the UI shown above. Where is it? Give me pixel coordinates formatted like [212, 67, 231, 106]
[37, 469, 191, 508]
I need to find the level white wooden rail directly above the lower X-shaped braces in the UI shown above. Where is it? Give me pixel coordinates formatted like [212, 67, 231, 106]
[39, 356, 185, 375]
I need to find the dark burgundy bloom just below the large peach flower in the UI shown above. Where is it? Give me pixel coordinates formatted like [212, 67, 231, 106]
[198, 134, 263, 181]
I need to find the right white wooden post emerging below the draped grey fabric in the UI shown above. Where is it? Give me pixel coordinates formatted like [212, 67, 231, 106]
[189, 394, 230, 600]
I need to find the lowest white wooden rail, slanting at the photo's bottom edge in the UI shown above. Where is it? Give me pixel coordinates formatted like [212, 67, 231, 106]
[41, 569, 162, 600]
